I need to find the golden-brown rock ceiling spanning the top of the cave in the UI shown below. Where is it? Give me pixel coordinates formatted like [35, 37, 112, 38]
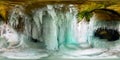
[0, 0, 120, 20]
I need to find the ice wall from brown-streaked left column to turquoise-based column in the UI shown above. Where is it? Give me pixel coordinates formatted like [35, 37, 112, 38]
[8, 4, 78, 50]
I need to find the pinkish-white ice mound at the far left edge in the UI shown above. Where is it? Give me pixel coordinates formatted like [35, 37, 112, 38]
[1, 24, 19, 48]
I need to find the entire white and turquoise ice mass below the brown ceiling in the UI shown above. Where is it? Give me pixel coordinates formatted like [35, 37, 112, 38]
[0, 4, 120, 59]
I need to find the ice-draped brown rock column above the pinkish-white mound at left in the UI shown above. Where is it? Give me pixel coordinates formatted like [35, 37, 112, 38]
[7, 5, 32, 47]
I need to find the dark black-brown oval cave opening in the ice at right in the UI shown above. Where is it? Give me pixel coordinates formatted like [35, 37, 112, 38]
[94, 28, 120, 42]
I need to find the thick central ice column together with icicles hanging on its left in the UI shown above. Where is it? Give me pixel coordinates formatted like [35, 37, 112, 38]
[33, 5, 58, 50]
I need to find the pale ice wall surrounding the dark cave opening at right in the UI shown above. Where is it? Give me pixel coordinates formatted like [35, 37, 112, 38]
[86, 9, 120, 48]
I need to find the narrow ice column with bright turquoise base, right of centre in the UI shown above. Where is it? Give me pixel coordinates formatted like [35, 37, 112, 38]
[65, 12, 77, 47]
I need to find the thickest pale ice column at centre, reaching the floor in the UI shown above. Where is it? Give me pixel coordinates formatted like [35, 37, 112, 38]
[42, 4, 58, 50]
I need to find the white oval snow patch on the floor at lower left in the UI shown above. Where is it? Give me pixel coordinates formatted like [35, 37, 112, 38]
[2, 49, 48, 59]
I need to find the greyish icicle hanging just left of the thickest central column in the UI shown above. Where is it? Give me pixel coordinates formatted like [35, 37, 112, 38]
[32, 9, 44, 41]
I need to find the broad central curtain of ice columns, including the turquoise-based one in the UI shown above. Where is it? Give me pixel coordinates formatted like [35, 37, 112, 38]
[33, 5, 77, 50]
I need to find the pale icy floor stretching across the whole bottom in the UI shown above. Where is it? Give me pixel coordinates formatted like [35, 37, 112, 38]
[0, 48, 120, 60]
